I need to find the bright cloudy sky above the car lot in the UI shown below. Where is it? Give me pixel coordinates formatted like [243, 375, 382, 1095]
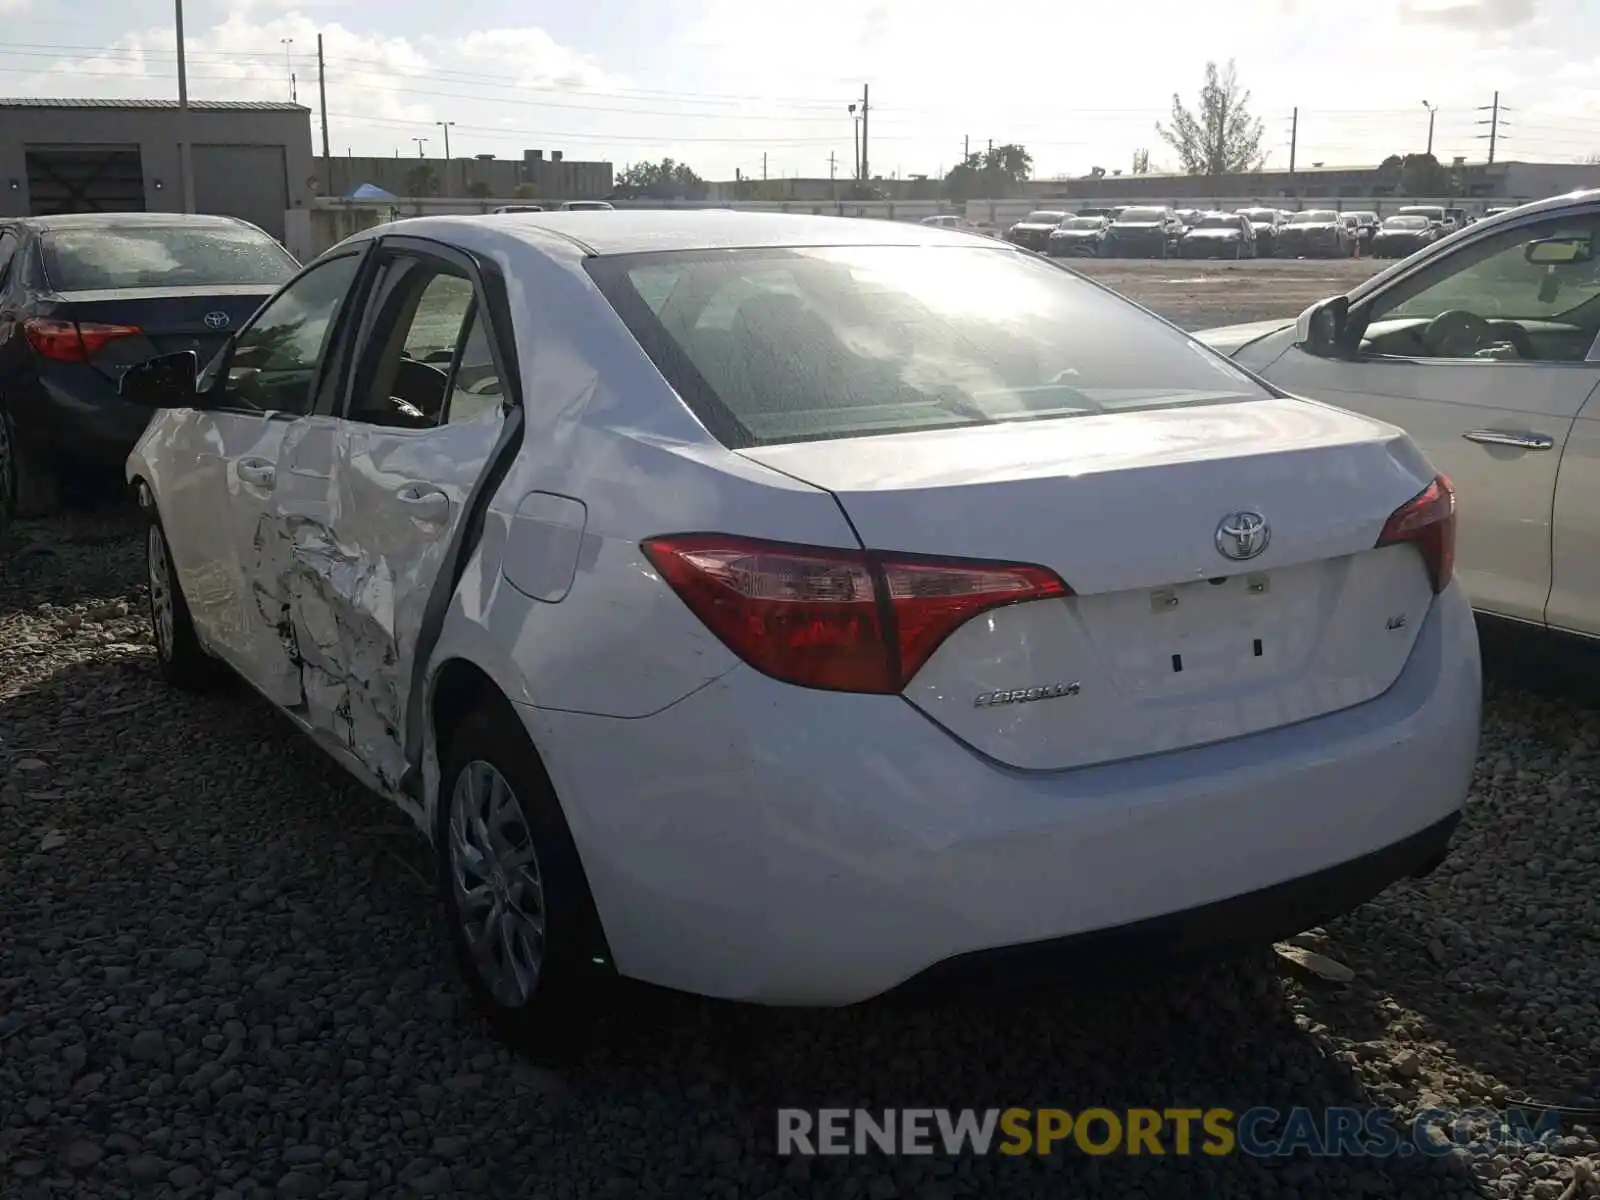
[0, 0, 1600, 178]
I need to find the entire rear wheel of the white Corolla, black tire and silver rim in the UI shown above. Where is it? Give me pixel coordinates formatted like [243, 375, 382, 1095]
[434, 704, 605, 1056]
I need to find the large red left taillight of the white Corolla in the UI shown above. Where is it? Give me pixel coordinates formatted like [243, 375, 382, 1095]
[642, 533, 1072, 693]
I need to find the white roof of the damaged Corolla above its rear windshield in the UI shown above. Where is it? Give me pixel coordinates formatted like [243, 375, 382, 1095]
[382, 208, 1017, 256]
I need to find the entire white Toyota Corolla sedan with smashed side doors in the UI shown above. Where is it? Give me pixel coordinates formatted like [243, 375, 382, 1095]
[123, 211, 1480, 1030]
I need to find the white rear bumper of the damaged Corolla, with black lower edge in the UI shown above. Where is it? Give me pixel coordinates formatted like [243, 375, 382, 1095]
[520, 586, 1482, 1005]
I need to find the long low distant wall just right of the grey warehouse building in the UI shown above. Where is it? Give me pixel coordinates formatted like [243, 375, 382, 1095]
[317, 155, 614, 203]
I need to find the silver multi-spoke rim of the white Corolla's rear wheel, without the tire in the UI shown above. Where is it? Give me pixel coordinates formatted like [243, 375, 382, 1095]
[446, 758, 546, 1008]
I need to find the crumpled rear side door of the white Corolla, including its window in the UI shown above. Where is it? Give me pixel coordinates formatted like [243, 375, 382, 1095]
[272, 244, 504, 790]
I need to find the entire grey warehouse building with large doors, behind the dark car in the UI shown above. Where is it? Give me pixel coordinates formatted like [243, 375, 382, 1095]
[0, 99, 314, 238]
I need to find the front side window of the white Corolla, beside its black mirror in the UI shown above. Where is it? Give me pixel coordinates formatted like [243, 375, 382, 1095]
[222, 254, 362, 414]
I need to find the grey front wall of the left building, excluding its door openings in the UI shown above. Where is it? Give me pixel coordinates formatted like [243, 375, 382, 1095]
[0, 106, 312, 234]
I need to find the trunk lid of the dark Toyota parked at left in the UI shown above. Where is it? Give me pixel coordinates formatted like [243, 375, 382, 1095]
[50, 285, 277, 379]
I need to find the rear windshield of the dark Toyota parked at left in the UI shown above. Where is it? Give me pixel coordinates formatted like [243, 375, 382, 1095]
[43, 226, 299, 291]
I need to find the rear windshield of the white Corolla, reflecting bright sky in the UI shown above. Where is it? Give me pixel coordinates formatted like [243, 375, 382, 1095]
[589, 246, 1269, 446]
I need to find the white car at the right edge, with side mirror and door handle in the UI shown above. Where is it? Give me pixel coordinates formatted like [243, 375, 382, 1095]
[1198, 190, 1600, 638]
